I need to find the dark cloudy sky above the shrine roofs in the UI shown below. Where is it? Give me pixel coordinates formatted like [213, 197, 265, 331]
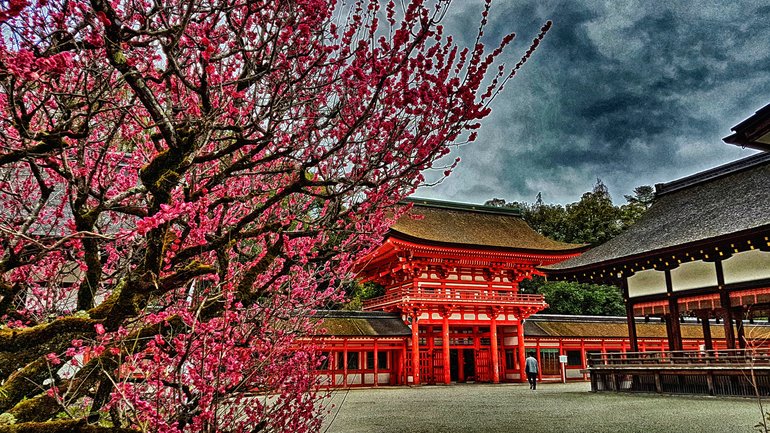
[415, 0, 770, 204]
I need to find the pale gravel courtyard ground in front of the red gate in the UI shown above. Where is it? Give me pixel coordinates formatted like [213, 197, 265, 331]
[321, 383, 770, 433]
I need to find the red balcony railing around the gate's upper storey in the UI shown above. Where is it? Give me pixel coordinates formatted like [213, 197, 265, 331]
[364, 289, 545, 310]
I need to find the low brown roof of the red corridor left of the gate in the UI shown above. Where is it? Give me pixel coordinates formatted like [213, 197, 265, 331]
[315, 311, 412, 337]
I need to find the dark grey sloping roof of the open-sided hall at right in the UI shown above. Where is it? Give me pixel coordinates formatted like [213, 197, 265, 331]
[544, 153, 770, 272]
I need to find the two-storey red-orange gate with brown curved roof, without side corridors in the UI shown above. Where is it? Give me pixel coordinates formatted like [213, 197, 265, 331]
[360, 199, 585, 384]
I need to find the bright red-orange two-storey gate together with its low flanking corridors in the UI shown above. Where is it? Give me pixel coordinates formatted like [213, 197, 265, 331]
[308, 200, 756, 387]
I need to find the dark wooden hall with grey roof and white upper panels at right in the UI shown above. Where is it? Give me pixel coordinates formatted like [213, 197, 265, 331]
[543, 106, 770, 394]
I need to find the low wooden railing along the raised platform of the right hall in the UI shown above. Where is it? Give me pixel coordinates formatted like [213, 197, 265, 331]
[588, 347, 770, 368]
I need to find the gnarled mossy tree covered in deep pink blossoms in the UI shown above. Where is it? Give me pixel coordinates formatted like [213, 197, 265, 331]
[0, 0, 549, 432]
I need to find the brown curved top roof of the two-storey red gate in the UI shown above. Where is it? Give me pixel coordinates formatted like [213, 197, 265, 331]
[391, 199, 584, 252]
